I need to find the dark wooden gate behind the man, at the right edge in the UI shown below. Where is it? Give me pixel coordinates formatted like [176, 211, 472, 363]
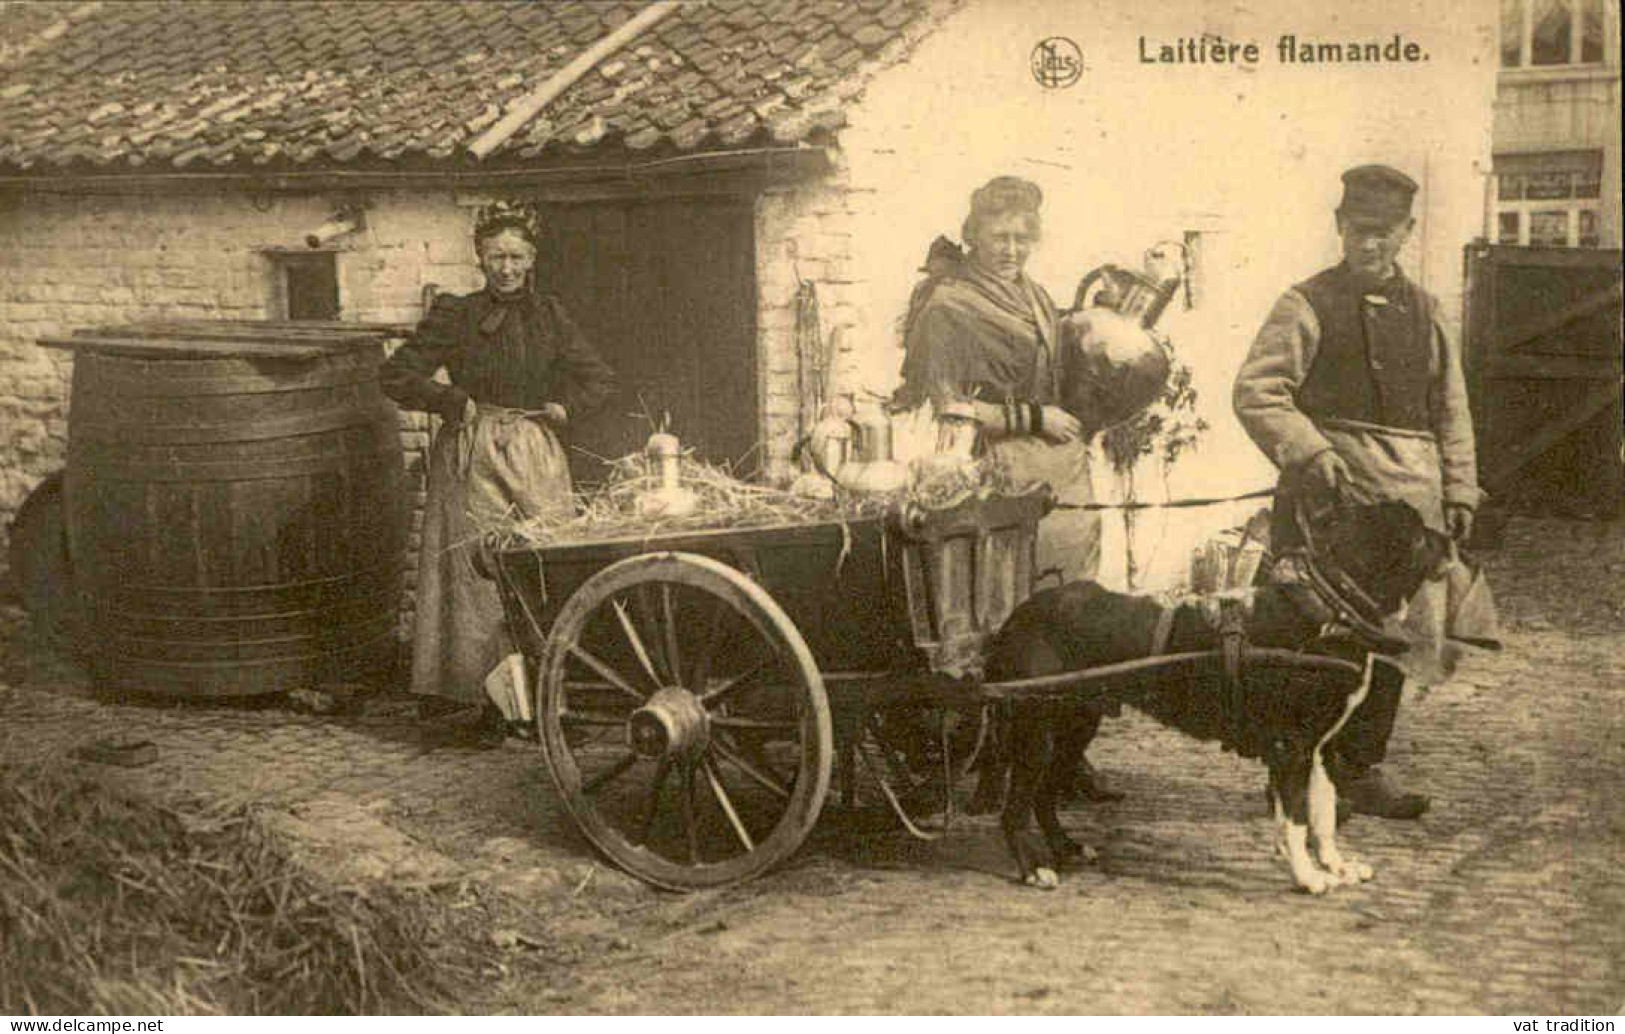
[1466, 244, 1625, 512]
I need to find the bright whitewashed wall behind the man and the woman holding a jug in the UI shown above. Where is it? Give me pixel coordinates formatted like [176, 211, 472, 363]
[761, 0, 1497, 587]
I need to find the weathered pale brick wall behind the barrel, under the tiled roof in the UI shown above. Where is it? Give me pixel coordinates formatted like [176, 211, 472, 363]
[0, 190, 479, 628]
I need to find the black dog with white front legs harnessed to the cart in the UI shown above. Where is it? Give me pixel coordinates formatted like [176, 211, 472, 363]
[983, 502, 1450, 894]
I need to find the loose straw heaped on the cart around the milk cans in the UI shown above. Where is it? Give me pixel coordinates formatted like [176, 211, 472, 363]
[494, 452, 1022, 548]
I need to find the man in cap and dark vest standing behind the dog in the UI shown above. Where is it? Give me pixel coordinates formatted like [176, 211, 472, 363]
[1232, 164, 1480, 819]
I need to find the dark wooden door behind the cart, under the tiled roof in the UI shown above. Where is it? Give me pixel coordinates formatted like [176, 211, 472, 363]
[536, 198, 761, 483]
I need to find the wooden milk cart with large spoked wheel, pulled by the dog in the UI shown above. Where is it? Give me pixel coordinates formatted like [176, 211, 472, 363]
[489, 489, 1051, 889]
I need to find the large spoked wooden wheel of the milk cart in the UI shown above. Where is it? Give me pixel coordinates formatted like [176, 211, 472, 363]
[536, 553, 834, 891]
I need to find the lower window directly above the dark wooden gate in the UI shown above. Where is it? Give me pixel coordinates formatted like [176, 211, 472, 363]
[1495, 151, 1602, 247]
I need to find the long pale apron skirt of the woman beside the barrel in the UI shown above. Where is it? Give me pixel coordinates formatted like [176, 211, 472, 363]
[411, 406, 570, 702]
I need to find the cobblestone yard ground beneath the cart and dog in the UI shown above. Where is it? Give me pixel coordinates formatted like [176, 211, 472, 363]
[0, 519, 1625, 1014]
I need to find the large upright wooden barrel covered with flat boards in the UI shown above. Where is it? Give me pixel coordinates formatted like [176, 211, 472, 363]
[46, 322, 406, 696]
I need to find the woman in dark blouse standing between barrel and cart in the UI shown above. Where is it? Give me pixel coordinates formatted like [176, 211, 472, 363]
[382, 203, 614, 704]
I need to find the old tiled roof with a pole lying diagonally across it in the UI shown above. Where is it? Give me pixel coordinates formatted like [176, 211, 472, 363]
[0, 0, 936, 174]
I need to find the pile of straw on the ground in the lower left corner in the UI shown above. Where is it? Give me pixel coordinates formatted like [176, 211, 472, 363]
[0, 766, 471, 1014]
